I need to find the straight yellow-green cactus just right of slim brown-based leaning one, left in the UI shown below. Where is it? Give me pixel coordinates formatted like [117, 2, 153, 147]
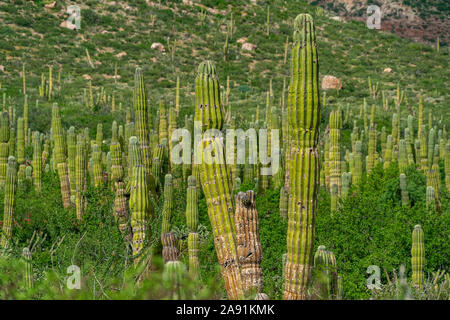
[75, 135, 87, 220]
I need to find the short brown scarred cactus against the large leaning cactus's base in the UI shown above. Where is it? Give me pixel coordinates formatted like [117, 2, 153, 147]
[234, 190, 263, 293]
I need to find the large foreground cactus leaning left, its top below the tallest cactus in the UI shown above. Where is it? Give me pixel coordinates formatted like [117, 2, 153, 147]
[194, 61, 243, 300]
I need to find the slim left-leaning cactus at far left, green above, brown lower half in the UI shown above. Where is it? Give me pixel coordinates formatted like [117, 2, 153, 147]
[52, 104, 70, 208]
